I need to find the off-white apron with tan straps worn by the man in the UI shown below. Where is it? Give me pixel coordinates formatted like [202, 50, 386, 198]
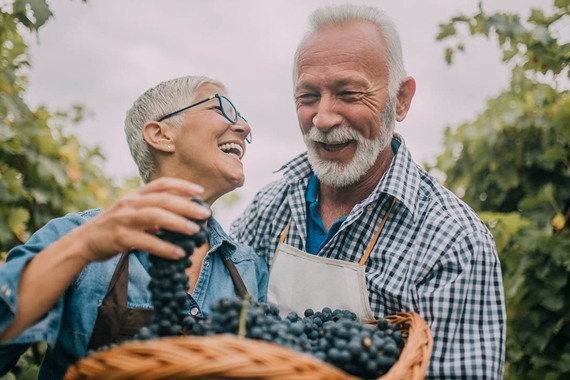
[267, 198, 396, 323]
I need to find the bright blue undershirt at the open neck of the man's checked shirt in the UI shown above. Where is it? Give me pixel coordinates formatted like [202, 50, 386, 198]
[305, 138, 400, 255]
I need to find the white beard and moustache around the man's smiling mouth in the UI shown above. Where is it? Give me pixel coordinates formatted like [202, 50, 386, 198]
[303, 98, 396, 188]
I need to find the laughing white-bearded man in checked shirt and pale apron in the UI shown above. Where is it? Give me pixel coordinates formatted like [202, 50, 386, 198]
[232, 5, 506, 379]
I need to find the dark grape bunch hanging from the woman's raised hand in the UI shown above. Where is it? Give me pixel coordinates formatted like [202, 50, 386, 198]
[135, 197, 208, 340]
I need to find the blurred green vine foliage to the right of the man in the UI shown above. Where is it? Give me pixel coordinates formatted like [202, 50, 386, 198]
[428, 0, 570, 379]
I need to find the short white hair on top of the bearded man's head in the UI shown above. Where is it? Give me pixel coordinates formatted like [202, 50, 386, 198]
[293, 4, 406, 96]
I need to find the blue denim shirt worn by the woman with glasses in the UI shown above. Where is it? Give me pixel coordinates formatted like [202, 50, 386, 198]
[0, 209, 268, 379]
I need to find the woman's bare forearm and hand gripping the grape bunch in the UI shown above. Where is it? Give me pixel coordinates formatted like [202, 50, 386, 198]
[0, 178, 210, 342]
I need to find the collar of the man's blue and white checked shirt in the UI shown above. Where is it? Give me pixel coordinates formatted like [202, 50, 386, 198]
[277, 133, 421, 220]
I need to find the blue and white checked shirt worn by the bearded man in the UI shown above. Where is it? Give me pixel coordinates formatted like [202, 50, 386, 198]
[230, 136, 506, 379]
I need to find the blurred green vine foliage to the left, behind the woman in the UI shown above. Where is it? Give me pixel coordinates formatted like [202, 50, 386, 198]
[0, 0, 140, 379]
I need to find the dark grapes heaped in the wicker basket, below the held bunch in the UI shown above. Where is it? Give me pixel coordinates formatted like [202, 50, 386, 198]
[182, 298, 404, 378]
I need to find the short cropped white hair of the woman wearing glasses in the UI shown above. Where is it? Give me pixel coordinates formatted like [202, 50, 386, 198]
[125, 76, 226, 183]
